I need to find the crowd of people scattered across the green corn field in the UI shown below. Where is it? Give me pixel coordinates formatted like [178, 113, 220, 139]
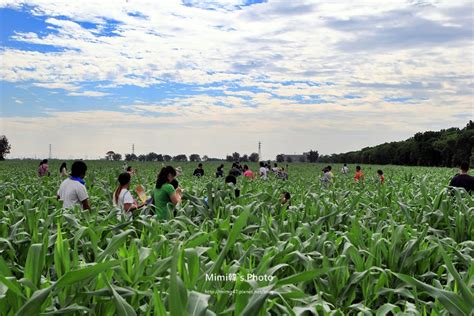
[38, 159, 474, 219]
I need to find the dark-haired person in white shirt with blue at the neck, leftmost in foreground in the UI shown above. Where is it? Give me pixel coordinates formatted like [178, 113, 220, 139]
[57, 160, 90, 210]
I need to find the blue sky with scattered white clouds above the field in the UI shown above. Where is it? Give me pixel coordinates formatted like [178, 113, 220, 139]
[0, 0, 474, 159]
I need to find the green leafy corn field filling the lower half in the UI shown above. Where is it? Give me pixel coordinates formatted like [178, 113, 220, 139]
[0, 161, 474, 315]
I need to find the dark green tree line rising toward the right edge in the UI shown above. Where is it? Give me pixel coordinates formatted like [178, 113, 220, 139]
[318, 121, 474, 167]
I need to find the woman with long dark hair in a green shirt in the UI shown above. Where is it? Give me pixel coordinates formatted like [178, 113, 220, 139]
[153, 166, 182, 219]
